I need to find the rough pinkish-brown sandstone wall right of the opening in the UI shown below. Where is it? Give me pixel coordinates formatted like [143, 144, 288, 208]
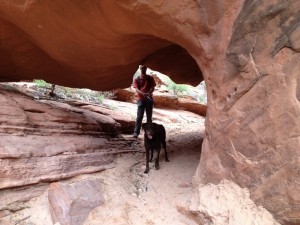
[196, 1, 300, 224]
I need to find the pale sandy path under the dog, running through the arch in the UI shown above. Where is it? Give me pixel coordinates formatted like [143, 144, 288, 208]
[84, 118, 203, 225]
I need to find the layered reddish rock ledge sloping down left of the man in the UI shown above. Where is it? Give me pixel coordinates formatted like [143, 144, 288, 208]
[0, 85, 134, 189]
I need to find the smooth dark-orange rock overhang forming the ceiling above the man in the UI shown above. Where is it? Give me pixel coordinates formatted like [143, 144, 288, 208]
[0, 0, 203, 90]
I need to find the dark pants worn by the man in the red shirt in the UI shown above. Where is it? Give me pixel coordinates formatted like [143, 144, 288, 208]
[134, 99, 153, 135]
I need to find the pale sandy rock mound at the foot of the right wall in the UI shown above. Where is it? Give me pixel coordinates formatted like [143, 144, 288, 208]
[191, 180, 279, 225]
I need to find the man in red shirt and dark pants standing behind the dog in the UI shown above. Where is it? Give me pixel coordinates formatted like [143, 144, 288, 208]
[133, 65, 156, 138]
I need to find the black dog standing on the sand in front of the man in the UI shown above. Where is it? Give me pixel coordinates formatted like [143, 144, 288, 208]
[142, 123, 169, 173]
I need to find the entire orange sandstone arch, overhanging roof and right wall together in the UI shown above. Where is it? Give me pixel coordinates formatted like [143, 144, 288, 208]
[0, 0, 300, 224]
